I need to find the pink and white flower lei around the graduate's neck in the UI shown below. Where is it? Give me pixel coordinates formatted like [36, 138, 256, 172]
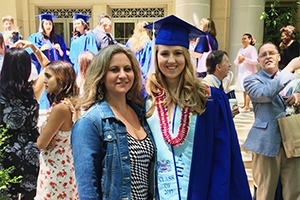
[155, 88, 191, 146]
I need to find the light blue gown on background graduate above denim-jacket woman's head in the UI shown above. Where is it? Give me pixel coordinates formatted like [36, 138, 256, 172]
[70, 32, 98, 74]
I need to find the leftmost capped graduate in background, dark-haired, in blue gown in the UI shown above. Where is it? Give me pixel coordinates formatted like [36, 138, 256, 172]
[27, 13, 67, 109]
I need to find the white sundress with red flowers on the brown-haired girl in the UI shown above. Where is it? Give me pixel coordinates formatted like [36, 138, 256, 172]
[35, 99, 78, 200]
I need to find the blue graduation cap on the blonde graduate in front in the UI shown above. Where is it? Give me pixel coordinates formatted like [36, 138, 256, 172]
[144, 15, 205, 49]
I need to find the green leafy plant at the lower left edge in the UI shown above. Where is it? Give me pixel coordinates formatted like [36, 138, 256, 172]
[0, 125, 22, 200]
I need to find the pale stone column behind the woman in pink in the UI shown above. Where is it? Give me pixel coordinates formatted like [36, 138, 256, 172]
[228, 0, 265, 86]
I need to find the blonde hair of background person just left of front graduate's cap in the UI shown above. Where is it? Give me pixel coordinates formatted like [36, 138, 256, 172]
[130, 21, 151, 53]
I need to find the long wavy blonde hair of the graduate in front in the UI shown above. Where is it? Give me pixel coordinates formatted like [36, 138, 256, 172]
[146, 45, 207, 117]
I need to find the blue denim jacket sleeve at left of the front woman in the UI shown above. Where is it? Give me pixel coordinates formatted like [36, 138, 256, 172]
[71, 117, 103, 200]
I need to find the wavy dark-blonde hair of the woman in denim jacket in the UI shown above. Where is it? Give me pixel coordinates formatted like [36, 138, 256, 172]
[76, 45, 143, 110]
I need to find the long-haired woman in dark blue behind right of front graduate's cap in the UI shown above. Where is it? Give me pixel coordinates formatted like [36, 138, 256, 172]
[193, 18, 219, 78]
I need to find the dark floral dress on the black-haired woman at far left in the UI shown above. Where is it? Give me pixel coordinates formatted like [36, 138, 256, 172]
[0, 94, 40, 199]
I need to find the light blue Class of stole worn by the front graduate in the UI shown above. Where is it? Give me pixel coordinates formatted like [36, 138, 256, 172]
[146, 99, 197, 200]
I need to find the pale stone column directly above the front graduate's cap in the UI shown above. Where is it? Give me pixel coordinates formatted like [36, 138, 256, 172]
[175, 0, 210, 26]
